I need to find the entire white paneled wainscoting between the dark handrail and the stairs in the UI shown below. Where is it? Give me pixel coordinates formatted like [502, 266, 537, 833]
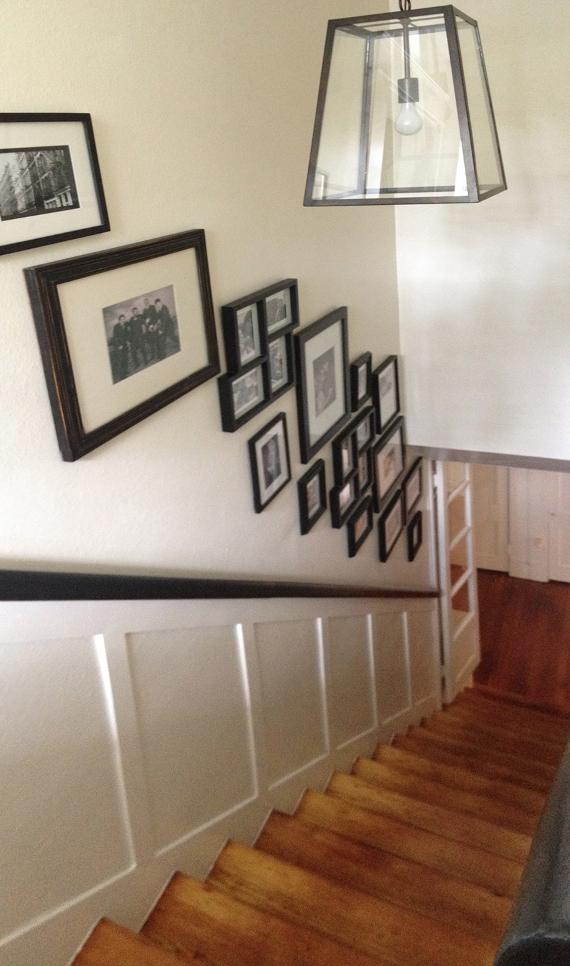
[0, 599, 440, 966]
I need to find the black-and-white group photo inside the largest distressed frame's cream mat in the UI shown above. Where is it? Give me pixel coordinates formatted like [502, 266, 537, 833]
[103, 285, 180, 383]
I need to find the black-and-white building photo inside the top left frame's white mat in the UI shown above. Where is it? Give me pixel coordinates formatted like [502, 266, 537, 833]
[0, 145, 80, 221]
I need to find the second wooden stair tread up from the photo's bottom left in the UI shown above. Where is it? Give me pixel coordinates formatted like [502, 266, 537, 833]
[143, 873, 378, 966]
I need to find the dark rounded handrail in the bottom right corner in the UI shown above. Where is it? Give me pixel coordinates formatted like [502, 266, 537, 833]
[495, 732, 570, 966]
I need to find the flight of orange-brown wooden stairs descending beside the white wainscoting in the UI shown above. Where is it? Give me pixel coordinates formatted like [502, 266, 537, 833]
[75, 689, 570, 966]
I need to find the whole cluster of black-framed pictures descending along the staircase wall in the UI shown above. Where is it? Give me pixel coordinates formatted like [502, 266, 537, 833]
[12, 114, 422, 562]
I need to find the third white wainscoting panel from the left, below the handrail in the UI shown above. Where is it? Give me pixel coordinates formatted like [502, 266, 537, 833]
[255, 620, 329, 785]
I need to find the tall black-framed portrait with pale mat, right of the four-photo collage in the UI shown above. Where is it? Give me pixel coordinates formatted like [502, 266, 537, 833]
[295, 308, 349, 463]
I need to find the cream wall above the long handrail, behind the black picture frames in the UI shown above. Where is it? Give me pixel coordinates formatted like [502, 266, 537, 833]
[0, 0, 426, 585]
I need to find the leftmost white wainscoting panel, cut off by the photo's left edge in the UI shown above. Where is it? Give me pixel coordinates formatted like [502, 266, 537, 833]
[0, 638, 133, 935]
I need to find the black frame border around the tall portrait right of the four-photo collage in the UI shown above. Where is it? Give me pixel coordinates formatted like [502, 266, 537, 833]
[295, 306, 351, 463]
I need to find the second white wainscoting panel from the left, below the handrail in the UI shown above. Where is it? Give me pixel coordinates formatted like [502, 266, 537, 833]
[128, 627, 256, 850]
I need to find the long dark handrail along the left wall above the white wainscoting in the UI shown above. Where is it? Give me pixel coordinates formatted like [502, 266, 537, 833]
[0, 570, 439, 601]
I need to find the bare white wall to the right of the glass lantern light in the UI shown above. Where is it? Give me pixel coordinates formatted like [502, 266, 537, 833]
[396, 0, 570, 460]
